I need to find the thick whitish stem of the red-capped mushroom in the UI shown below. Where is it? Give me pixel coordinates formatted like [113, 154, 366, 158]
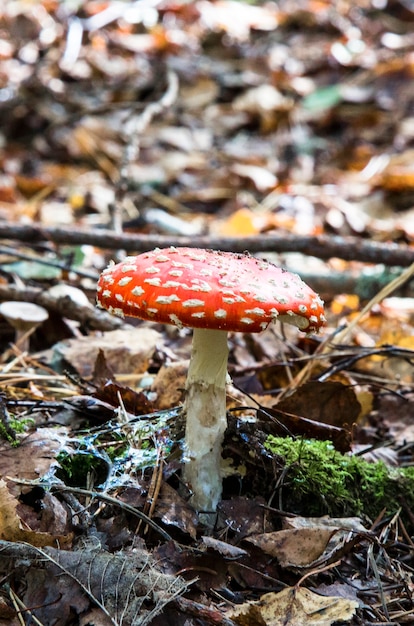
[183, 328, 228, 512]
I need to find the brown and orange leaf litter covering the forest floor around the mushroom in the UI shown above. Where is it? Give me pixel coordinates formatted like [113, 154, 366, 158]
[0, 0, 414, 626]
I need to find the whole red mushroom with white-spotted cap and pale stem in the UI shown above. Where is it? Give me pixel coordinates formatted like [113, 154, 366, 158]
[97, 248, 326, 512]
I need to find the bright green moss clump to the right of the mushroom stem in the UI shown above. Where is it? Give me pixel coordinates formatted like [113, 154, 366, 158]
[265, 436, 414, 520]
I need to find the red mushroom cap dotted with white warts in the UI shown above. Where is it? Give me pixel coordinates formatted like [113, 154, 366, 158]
[97, 248, 326, 332]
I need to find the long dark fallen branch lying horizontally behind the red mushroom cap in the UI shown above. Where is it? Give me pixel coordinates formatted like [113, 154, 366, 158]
[0, 222, 414, 267]
